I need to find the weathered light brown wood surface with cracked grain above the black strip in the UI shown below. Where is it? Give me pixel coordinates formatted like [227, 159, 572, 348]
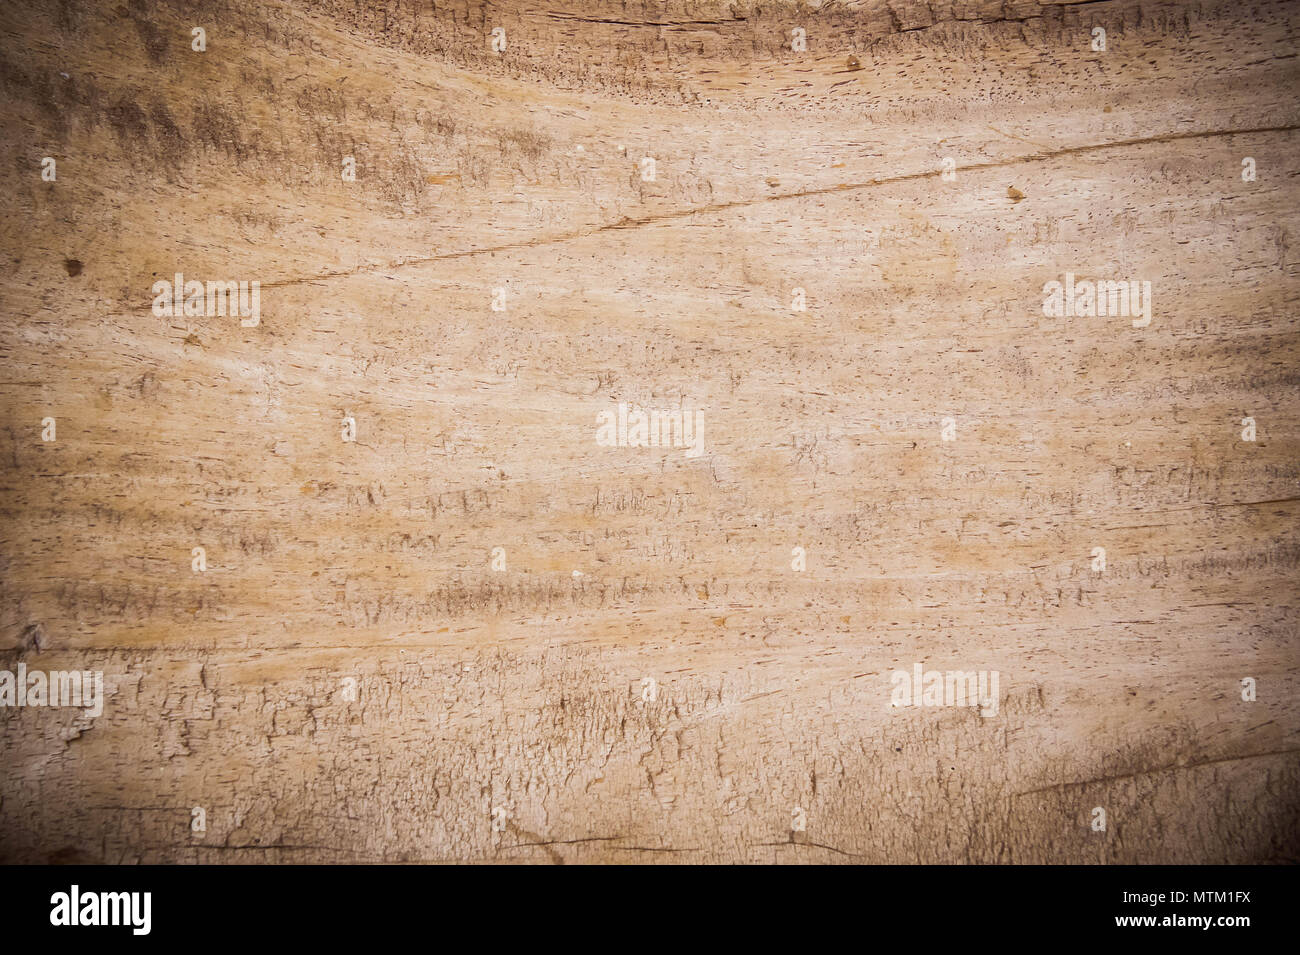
[0, 0, 1300, 863]
